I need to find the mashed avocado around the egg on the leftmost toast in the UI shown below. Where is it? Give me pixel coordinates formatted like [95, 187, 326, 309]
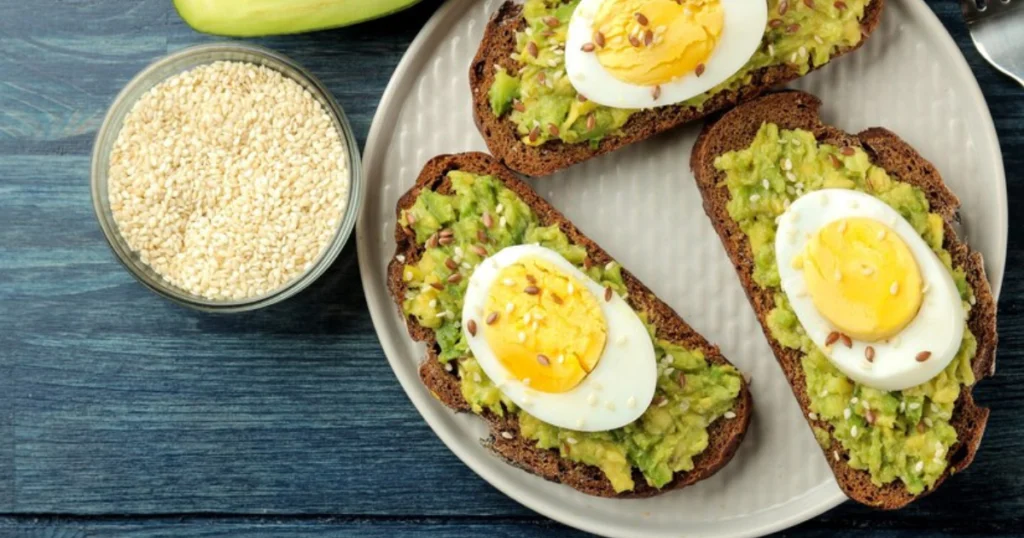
[400, 171, 741, 492]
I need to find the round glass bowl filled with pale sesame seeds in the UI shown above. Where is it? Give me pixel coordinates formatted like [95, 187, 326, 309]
[92, 43, 362, 313]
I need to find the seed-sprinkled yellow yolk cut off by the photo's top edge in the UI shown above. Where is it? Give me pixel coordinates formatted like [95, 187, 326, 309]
[594, 0, 725, 86]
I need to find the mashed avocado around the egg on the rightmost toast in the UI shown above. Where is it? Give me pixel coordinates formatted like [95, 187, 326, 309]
[715, 124, 977, 494]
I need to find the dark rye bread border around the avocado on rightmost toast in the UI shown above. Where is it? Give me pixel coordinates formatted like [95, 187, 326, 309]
[690, 91, 996, 509]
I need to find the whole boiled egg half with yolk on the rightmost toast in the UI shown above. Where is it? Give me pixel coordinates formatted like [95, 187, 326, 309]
[775, 189, 965, 390]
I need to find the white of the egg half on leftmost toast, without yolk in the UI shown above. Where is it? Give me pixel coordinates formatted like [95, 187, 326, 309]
[462, 245, 657, 431]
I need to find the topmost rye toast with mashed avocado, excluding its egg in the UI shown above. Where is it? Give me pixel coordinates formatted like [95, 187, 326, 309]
[469, 0, 885, 176]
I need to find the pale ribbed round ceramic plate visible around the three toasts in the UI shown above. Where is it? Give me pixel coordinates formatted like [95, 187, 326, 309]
[357, 0, 1007, 537]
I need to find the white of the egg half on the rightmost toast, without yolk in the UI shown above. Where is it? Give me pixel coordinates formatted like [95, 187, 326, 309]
[775, 189, 966, 390]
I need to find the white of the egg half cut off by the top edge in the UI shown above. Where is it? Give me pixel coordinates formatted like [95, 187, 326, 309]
[565, 0, 768, 109]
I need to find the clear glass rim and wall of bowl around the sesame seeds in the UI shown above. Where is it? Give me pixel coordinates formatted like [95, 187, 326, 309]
[92, 43, 364, 313]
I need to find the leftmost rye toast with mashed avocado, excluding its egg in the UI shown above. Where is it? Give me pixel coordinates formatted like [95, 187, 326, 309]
[388, 153, 752, 497]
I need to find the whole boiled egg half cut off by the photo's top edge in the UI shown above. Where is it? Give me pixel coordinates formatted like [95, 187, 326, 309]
[565, 0, 768, 109]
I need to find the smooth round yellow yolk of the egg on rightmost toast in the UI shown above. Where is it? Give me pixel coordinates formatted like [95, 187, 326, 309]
[798, 217, 922, 342]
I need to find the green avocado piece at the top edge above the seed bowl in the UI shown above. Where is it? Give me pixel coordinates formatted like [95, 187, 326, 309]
[174, 0, 419, 37]
